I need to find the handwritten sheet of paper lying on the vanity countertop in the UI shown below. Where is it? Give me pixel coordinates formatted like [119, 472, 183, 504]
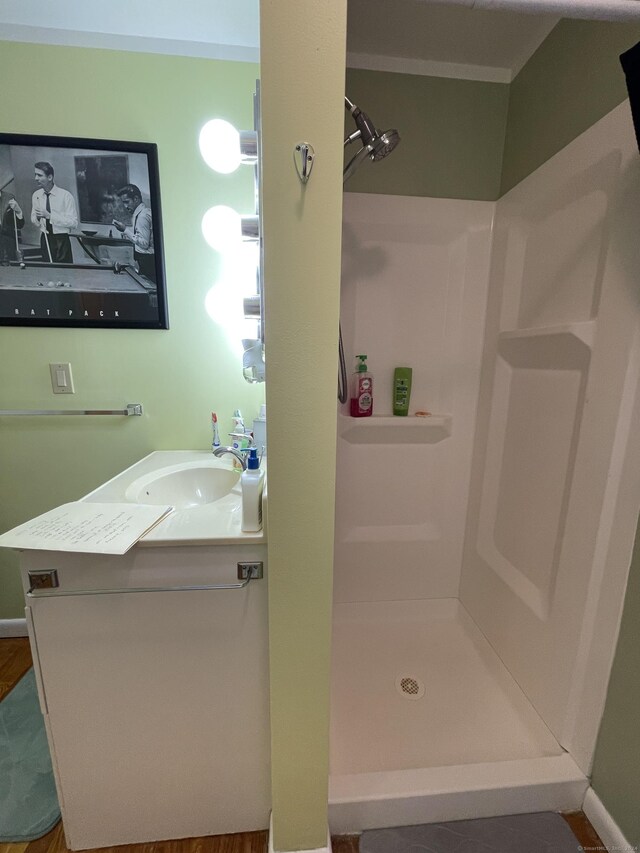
[0, 501, 173, 554]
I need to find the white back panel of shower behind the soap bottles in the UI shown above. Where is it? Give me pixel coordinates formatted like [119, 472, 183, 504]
[334, 193, 495, 602]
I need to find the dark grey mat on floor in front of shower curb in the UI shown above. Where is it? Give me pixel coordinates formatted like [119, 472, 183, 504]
[360, 812, 586, 853]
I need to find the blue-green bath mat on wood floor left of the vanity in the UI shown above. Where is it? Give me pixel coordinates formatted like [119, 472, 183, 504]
[0, 669, 60, 842]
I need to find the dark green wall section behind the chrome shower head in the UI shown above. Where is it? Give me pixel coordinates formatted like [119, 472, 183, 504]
[345, 68, 509, 201]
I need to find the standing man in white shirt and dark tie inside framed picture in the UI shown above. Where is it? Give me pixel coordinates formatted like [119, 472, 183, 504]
[31, 161, 78, 264]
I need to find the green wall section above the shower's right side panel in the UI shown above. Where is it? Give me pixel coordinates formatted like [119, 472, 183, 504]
[500, 20, 640, 195]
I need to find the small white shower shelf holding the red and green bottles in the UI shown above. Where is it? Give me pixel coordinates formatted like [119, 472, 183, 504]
[338, 415, 451, 444]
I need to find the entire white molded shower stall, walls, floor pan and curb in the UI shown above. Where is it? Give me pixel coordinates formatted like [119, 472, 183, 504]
[329, 102, 640, 832]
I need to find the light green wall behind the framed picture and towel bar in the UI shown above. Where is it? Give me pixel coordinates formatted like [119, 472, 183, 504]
[0, 43, 264, 618]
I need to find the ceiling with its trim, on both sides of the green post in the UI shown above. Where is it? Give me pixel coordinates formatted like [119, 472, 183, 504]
[0, 0, 558, 82]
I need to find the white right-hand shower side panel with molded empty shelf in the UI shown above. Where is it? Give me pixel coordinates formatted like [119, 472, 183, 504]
[460, 103, 640, 773]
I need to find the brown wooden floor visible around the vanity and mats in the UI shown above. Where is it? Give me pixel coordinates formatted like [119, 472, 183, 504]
[0, 637, 605, 853]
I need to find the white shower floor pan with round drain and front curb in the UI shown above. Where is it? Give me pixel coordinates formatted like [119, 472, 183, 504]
[329, 599, 588, 833]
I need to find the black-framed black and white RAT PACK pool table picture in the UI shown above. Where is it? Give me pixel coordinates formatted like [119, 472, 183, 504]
[0, 133, 169, 329]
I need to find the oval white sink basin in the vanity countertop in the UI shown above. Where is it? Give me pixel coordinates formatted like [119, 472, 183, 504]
[125, 459, 240, 509]
